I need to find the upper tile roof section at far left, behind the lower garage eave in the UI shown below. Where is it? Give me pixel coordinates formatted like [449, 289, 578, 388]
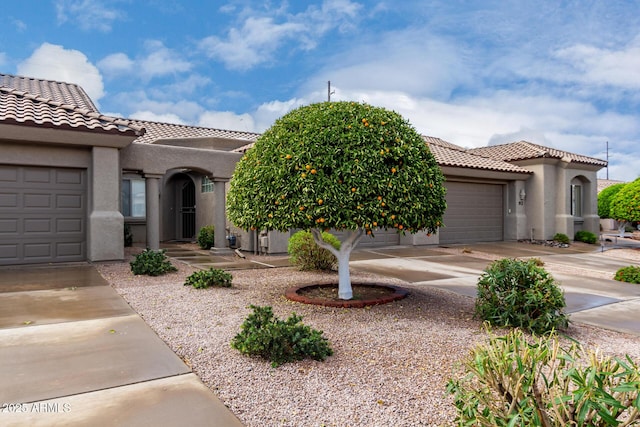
[0, 74, 98, 113]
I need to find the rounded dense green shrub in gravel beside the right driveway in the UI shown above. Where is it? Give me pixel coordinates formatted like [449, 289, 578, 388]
[475, 259, 568, 333]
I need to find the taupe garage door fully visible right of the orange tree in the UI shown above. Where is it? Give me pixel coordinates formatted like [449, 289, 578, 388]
[440, 182, 504, 243]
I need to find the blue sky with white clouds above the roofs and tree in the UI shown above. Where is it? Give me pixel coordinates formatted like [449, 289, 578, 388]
[0, 0, 640, 181]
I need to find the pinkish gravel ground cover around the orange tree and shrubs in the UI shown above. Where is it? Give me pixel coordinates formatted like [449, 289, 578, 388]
[97, 244, 640, 427]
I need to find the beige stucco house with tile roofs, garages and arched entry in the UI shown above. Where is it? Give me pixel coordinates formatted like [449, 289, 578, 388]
[0, 74, 606, 265]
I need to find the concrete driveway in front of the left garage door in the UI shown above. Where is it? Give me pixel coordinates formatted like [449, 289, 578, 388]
[0, 264, 242, 427]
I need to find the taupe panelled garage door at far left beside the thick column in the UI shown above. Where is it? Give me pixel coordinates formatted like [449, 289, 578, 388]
[0, 165, 86, 265]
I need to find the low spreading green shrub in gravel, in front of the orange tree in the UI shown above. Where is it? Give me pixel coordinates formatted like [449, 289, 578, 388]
[231, 305, 333, 368]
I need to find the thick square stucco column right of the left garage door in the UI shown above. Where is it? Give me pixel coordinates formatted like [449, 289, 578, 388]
[87, 147, 124, 261]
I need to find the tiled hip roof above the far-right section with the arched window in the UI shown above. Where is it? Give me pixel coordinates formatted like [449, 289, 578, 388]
[468, 141, 607, 166]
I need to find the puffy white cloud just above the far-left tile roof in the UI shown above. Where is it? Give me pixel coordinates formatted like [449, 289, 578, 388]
[17, 43, 104, 103]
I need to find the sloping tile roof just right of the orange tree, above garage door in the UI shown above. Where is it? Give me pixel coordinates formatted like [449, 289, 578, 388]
[423, 136, 532, 174]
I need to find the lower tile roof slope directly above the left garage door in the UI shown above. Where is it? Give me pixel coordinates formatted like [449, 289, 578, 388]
[0, 87, 144, 135]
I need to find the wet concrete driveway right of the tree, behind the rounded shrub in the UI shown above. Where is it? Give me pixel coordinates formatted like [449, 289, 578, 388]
[351, 242, 640, 336]
